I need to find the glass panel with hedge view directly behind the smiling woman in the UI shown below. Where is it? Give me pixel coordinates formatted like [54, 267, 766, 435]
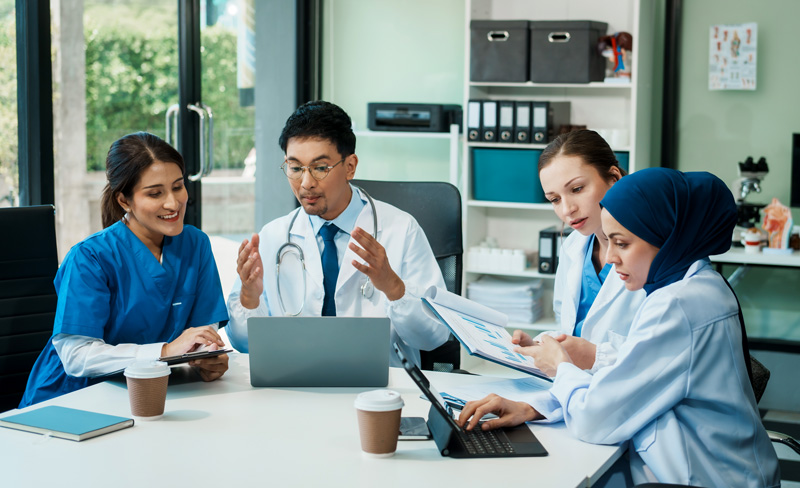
[52, 0, 178, 257]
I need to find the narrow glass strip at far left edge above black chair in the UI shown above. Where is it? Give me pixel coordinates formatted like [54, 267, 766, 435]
[0, 0, 19, 207]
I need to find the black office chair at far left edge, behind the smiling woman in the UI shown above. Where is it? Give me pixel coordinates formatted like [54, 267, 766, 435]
[0, 205, 58, 411]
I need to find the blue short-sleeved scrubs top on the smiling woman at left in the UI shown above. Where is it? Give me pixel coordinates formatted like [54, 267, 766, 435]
[19, 221, 228, 408]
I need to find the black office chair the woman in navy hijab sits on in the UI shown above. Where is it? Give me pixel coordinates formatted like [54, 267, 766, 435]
[635, 276, 800, 488]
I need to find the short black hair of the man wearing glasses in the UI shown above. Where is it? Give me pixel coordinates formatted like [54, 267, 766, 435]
[278, 100, 356, 158]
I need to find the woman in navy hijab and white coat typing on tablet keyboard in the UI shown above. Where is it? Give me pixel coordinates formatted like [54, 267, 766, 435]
[460, 168, 780, 487]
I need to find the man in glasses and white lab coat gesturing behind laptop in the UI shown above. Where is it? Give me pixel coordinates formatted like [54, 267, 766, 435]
[227, 101, 449, 364]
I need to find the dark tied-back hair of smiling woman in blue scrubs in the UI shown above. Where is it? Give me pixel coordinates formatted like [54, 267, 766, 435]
[100, 132, 186, 228]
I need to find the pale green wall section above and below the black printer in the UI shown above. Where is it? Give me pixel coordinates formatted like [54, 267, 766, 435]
[322, 0, 465, 181]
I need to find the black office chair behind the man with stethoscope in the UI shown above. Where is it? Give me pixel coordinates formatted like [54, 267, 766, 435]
[353, 180, 464, 371]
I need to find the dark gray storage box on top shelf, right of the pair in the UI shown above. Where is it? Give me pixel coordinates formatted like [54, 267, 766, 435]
[530, 20, 608, 83]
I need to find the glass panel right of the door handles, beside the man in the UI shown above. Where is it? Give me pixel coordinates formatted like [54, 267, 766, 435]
[200, 0, 253, 239]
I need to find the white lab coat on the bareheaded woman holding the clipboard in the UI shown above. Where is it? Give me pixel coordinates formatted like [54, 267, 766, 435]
[536, 232, 645, 372]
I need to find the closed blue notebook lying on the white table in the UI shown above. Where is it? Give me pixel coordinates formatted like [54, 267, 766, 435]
[0, 406, 133, 441]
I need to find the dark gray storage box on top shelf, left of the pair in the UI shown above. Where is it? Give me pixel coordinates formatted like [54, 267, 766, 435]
[469, 20, 530, 82]
